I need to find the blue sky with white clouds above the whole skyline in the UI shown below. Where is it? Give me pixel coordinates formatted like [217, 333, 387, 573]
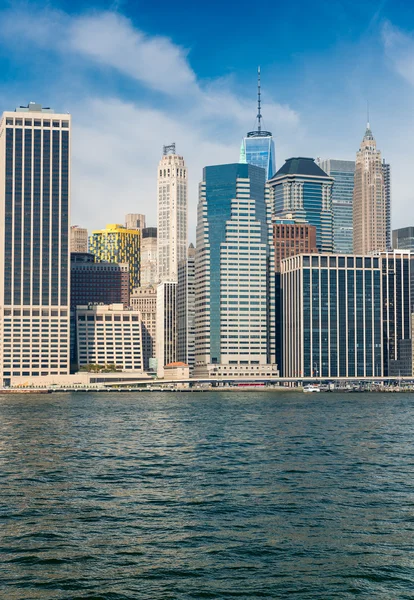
[0, 0, 414, 238]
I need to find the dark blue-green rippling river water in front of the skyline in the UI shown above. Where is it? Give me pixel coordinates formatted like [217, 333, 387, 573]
[0, 391, 414, 600]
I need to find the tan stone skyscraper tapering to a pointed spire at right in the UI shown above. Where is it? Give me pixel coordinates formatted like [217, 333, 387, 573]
[353, 123, 387, 254]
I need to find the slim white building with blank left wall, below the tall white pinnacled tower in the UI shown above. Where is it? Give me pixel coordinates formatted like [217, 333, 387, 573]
[155, 281, 177, 377]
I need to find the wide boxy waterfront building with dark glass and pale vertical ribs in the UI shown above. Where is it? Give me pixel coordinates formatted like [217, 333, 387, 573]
[281, 255, 382, 378]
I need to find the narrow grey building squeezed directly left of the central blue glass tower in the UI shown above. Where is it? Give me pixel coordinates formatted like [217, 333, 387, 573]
[177, 244, 195, 372]
